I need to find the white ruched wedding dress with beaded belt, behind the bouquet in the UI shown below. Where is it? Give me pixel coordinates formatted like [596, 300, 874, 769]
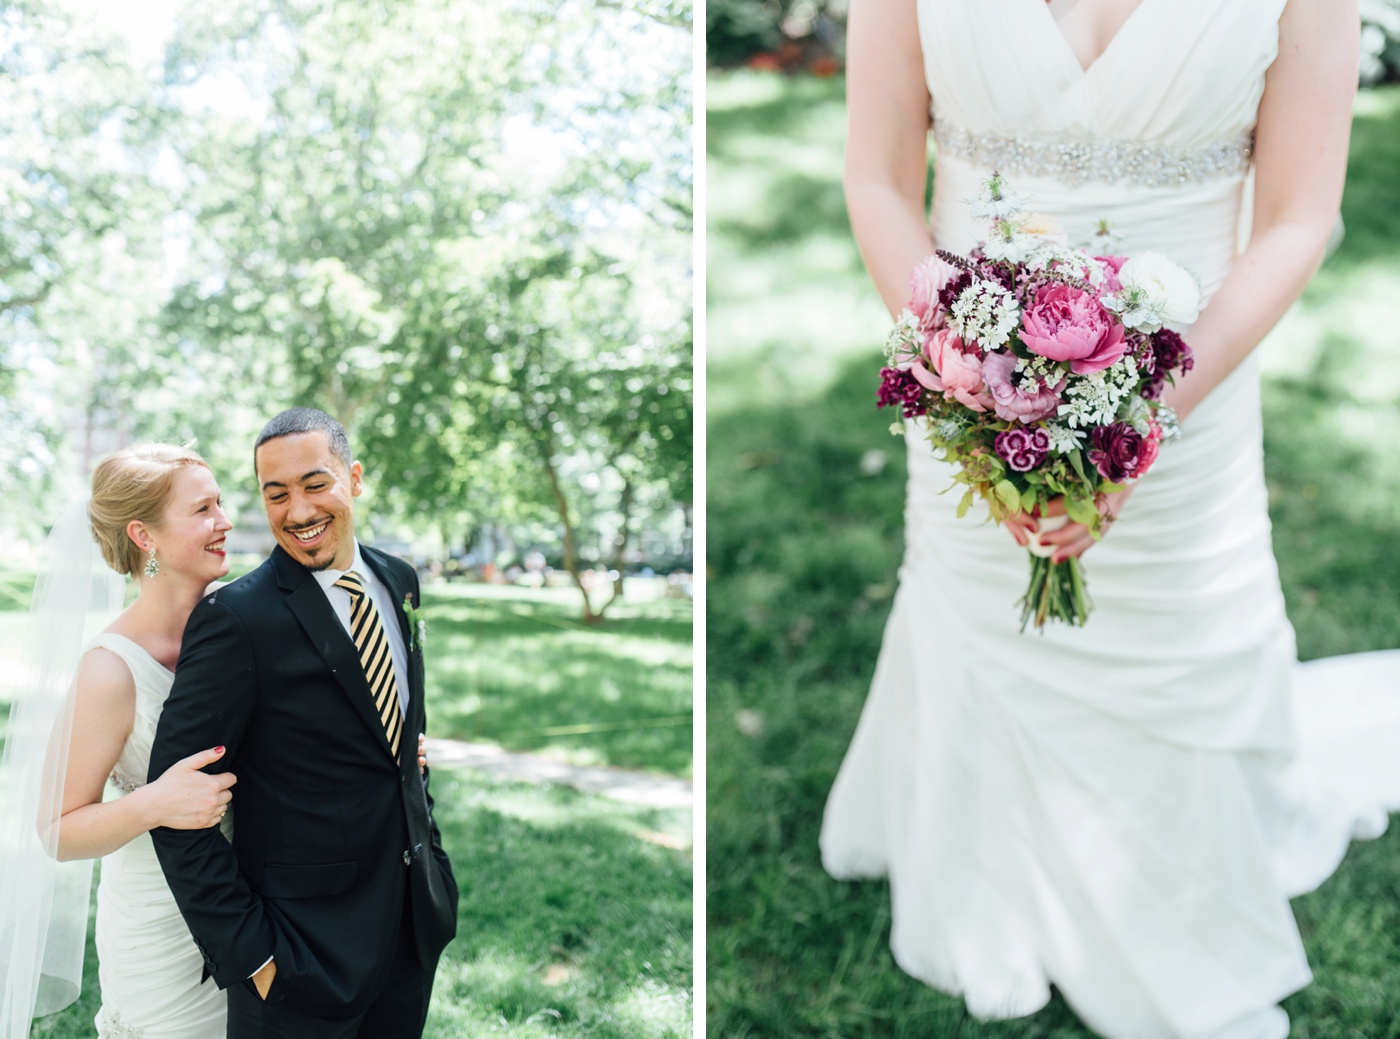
[822, 0, 1400, 1039]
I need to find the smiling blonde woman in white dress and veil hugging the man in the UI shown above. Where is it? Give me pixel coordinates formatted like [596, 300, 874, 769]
[0, 444, 426, 1039]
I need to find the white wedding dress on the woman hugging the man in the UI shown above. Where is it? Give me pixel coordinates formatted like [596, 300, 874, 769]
[90, 633, 224, 1039]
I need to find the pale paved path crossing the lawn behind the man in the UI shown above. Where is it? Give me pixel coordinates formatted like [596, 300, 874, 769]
[428, 738, 694, 808]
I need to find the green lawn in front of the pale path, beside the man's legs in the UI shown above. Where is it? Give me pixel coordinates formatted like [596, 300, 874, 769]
[32, 769, 692, 1039]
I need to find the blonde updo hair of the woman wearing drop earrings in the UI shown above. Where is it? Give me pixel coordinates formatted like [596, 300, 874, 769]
[88, 444, 209, 574]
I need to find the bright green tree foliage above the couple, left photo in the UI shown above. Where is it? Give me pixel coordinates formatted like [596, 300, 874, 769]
[0, 0, 692, 576]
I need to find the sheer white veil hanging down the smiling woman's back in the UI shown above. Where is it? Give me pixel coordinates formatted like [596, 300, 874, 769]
[0, 498, 125, 1039]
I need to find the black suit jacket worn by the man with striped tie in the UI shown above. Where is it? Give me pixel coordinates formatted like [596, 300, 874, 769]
[150, 546, 458, 1018]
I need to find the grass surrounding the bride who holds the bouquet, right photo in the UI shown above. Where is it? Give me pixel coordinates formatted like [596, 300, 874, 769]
[706, 73, 1400, 1039]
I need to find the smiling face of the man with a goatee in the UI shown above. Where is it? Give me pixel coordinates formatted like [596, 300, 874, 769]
[255, 430, 361, 570]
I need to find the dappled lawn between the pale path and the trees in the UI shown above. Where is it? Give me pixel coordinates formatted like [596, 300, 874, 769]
[424, 588, 693, 776]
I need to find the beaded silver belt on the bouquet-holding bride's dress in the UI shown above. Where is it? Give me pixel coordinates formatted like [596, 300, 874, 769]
[934, 116, 1254, 188]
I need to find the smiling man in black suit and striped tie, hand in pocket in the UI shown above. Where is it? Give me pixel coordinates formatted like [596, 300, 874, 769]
[150, 407, 456, 1039]
